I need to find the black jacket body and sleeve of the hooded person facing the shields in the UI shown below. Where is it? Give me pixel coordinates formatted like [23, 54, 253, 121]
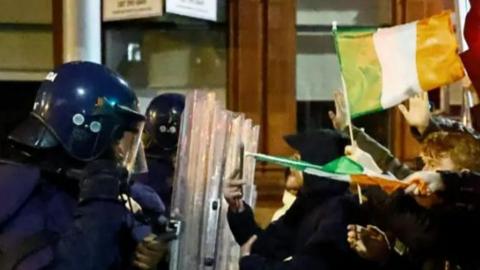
[228, 194, 376, 270]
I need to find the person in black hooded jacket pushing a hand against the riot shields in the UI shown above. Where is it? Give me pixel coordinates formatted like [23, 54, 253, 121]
[225, 130, 378, 270]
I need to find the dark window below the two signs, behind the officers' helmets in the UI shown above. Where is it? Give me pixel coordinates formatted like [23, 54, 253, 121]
[104, 15, 228, 109]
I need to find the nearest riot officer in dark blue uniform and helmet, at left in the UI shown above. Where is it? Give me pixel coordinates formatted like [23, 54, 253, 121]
[0, 62, 165, 270]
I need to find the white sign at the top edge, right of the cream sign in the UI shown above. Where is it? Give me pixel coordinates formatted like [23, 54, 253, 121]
[166, 0, 218, 21]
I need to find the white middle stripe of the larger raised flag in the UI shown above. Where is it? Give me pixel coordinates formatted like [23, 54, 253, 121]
[373, 22, 421, 109]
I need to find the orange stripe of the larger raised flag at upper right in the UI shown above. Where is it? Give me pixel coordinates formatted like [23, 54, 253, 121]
[416, 11, 464, 91]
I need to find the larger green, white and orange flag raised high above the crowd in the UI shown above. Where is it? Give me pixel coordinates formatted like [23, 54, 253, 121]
[334, 12, 464, 117]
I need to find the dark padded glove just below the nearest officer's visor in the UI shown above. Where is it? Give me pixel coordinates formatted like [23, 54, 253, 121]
[79, 160, 128, 203]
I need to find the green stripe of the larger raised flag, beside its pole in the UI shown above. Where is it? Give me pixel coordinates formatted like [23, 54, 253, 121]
[335, 29, 382, 118]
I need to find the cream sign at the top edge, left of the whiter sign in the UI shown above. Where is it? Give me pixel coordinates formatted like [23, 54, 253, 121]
[103, 0, 163, 21]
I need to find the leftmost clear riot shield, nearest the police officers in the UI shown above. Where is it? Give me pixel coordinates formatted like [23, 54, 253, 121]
[171, 92, 215, 269]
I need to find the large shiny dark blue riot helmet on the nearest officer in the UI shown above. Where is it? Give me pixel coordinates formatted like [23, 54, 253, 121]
[9, 62, 145, 161]
